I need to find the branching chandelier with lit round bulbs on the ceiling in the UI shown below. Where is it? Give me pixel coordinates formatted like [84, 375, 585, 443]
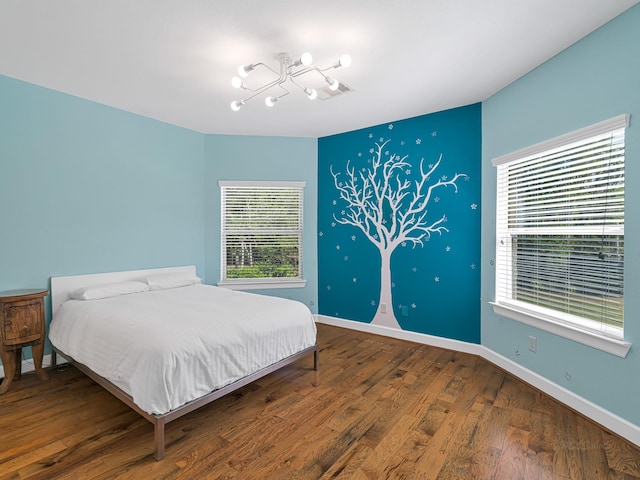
[231, 53, 351, 112]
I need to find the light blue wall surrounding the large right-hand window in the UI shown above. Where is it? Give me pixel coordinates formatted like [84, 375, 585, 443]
[481, 5, 640, 425]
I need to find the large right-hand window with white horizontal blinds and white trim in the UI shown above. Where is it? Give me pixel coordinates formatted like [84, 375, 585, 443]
[493, 115, 628, 356]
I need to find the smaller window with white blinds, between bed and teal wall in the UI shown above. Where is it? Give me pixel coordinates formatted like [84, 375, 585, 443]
[220, 182, 305, 289]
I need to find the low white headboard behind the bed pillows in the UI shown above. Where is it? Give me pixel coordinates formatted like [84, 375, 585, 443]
[51, 265, 196, 315]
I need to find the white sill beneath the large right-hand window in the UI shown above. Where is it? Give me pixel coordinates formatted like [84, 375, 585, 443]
[489, 302, 631, 358]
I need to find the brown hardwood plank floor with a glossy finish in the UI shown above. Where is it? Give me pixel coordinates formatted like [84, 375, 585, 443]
[0, 324, 640, 480]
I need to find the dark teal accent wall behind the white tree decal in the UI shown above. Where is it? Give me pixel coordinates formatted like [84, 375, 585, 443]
[318, 104, 481, 343]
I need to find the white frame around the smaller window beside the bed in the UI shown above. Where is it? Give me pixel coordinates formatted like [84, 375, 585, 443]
[218, 180, 306, 290]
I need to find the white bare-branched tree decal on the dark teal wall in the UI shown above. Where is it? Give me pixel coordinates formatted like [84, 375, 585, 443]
[329, 140, 468, 328]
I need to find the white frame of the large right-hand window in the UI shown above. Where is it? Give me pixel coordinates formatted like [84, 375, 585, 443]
[489, 114, 631, 358]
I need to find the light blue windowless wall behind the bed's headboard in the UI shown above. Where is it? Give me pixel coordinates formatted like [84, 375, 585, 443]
[0, 76, 205, 346]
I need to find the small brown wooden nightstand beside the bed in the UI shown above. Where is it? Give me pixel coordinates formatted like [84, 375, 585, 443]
[0, 290, 49, 395]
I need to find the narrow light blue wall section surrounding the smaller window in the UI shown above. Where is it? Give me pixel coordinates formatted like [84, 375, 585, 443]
[205, 135, 318, 313]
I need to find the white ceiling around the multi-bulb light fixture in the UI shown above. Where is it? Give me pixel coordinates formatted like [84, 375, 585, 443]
[0, 0, 640, 137]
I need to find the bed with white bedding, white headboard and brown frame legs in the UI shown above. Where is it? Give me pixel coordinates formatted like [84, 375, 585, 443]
[49, 266, 318, 460]
